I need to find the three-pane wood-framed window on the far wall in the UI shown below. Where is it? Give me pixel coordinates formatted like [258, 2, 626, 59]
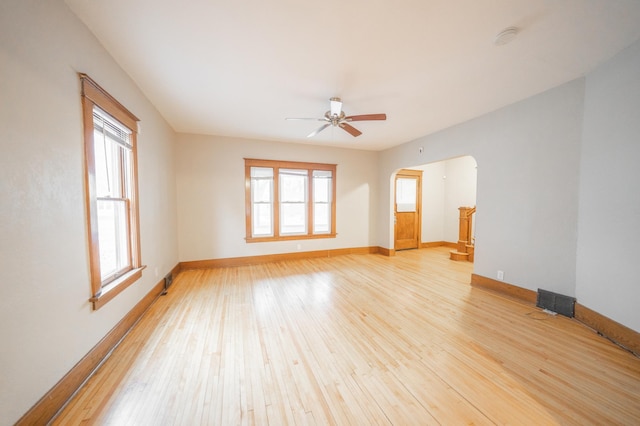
[245, 159, 336, 242]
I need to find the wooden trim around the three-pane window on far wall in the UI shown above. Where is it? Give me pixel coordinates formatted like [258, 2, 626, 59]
[244, 158, 337, 243]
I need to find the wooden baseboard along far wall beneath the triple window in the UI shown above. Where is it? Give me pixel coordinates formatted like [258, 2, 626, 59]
[180, 247, 381, 269]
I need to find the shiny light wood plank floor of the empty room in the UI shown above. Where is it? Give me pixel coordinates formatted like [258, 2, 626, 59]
[55, 249, 640, 425]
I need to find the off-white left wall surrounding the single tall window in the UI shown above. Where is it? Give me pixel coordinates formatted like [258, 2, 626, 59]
[0, 0, 178, 425]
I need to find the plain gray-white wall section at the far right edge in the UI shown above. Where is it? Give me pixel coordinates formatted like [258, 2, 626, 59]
[576, 38, 640, 331]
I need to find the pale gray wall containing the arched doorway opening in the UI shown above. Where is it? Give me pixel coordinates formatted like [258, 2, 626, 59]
[376, 79, 584, 295]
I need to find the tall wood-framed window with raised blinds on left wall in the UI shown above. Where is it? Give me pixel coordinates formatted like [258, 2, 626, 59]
[80, 74, 143, 309]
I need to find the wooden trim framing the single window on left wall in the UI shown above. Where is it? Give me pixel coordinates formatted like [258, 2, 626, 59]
[78, 73, 144, 310]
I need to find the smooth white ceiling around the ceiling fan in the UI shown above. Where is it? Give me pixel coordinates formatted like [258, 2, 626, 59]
[66, 0, 640, 150]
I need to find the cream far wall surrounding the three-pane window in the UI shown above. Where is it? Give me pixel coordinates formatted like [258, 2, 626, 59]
[177, 134, 378, 261]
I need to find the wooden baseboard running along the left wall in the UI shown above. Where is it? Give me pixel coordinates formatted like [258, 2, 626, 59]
[16, 264, 180, 426]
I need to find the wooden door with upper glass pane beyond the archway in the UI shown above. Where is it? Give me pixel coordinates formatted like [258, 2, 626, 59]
[393, 169, 422, 250]
